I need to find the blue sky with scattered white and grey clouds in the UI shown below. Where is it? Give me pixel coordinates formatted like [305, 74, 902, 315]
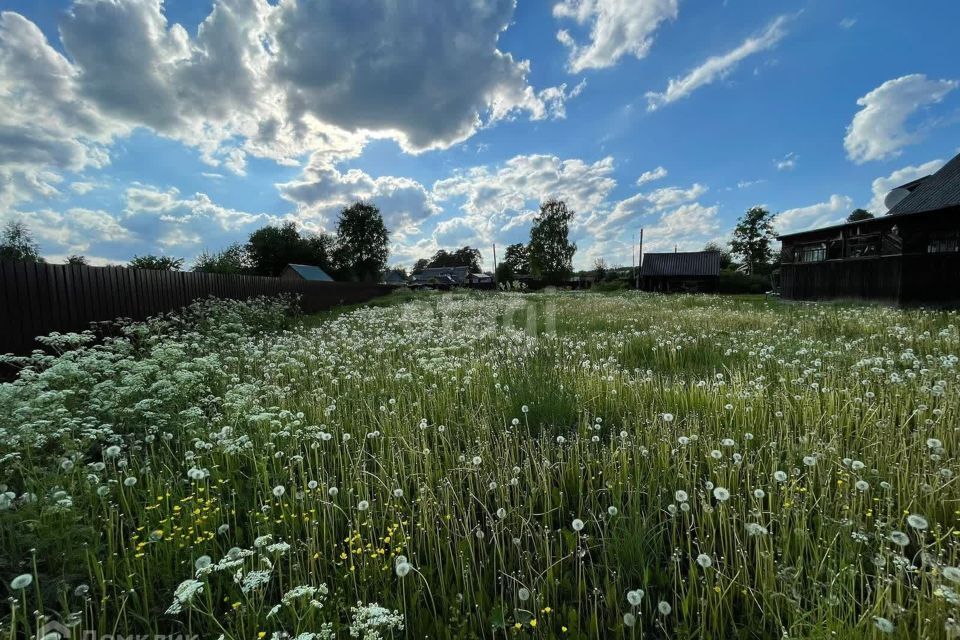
[0, 0, 960, 270]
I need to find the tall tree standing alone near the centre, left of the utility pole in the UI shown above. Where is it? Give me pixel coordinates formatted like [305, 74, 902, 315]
[529, 200, 577, 284]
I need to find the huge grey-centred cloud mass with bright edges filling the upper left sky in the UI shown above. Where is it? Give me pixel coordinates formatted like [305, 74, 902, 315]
[0, 0, 568, 206]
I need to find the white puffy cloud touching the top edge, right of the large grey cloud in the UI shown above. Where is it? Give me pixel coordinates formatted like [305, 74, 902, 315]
[553, 0, 677, 73]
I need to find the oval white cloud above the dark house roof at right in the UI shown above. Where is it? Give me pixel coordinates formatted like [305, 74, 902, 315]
[843, 73, 958, 164]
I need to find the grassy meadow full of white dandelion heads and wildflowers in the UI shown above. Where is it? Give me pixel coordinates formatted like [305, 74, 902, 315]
[0, 292, 960, 640]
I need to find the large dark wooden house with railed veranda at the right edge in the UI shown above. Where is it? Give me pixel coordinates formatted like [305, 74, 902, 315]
[778, 150, 960, 304]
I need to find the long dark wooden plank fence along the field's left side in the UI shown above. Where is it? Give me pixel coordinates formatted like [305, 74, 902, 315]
[0, 261, 390, 354]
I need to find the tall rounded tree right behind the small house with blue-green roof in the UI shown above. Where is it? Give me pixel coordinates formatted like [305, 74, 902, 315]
[334, 202, 389, 281]
